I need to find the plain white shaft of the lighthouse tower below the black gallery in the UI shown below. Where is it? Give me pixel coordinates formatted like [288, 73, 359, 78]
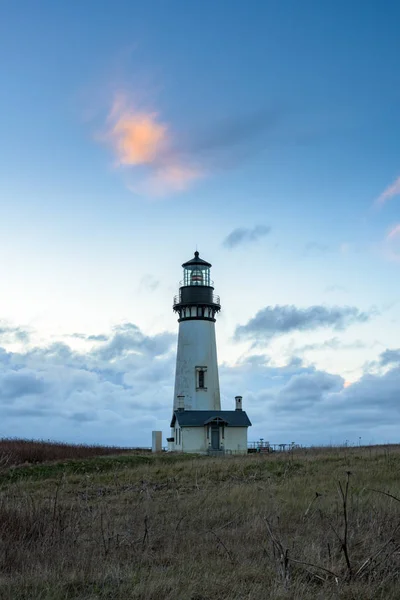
[174, 319, 221, 410]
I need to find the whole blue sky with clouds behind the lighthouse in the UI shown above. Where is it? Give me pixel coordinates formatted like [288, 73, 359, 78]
[0, 0, 400, 446]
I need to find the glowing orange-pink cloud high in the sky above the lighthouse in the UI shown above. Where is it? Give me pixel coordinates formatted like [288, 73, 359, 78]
[105, 95, 203, 196]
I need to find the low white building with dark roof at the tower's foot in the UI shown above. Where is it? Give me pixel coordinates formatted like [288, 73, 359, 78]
[168, 396, 251, 454]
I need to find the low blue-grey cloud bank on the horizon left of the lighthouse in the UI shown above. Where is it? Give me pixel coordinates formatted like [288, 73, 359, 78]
[0, 323, 176, 446]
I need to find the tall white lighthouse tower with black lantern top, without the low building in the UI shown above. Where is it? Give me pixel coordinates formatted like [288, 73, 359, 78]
[173, 251, 221, 410]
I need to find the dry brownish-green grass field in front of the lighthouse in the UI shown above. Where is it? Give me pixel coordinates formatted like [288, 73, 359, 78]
[0, 446, 400, 600]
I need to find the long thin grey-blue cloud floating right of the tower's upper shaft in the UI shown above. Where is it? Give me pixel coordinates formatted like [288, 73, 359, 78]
[235, 305, 371, 341]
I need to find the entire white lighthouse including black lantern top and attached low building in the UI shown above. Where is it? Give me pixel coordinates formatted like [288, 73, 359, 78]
[167, 251, 251, 454]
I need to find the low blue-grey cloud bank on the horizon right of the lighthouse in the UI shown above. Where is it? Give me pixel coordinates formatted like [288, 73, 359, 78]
[220, 357, 400, 445]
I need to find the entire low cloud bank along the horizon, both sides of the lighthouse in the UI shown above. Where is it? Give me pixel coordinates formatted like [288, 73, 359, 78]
[0, 323, 400, 446]
